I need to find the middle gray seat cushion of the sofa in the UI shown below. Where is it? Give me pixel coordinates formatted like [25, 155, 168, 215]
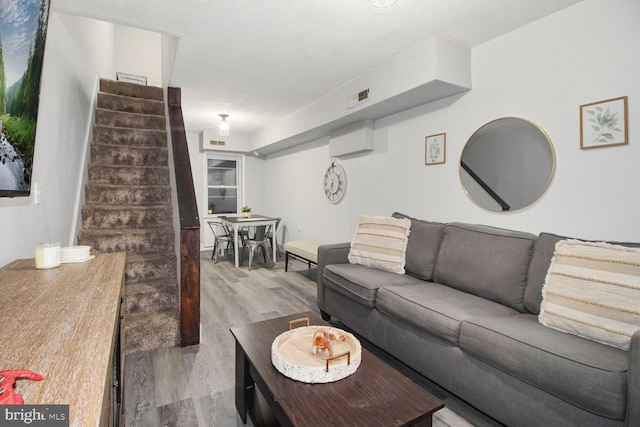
[376, 282, 518, 345]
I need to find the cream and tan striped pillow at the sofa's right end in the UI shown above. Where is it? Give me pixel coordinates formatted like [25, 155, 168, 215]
[538, 240, 640, 350]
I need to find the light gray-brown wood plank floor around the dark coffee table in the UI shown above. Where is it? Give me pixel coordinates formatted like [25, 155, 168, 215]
[124, 251, 499, 427]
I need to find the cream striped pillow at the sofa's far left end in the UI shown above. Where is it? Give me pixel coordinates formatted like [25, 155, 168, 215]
[349, 215, 411, 274]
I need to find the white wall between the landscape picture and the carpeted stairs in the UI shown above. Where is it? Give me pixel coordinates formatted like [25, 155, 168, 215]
[0, 10, 113, 265]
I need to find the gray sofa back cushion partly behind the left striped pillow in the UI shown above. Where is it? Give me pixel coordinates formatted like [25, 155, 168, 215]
[392, 212, 446, 281]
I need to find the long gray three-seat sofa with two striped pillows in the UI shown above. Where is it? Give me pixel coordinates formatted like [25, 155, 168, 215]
[318, 213, 640, 426]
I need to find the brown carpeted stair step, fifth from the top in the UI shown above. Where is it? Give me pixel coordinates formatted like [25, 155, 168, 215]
[91, 144, 169, 166]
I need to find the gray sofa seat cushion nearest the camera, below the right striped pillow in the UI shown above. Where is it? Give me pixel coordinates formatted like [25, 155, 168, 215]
[460, 314, 628, 419]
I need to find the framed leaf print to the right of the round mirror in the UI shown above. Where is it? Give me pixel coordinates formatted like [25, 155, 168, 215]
[580, 96, 629, 150]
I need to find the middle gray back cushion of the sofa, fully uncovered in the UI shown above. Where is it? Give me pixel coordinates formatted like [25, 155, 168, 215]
[433, 223, 536, 312]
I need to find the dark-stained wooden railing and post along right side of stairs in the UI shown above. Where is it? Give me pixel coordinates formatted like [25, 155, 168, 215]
[167, 87, 200, 347]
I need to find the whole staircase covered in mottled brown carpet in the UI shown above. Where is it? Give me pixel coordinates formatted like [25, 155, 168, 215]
[78, 79, 179, 354]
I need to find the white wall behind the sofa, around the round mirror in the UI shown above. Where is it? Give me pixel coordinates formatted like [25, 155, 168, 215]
[265, 0, 640, 243]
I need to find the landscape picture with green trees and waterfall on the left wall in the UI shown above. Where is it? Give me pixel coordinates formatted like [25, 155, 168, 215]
[0, 0, 49, 197]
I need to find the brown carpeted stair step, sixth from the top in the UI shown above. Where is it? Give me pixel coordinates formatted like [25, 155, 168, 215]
[89, 163, 170, 185]
